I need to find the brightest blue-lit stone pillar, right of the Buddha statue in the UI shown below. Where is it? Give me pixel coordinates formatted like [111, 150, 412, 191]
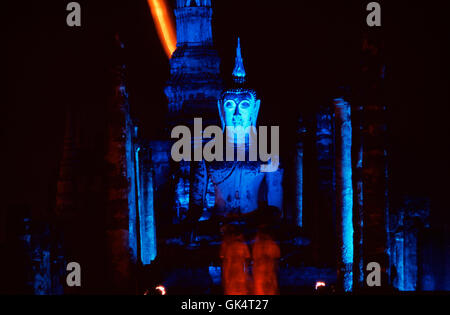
[334, 98, 353, 292]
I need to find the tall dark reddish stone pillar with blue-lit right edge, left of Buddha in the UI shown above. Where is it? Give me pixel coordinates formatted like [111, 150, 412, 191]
[105, 37, 137, 293]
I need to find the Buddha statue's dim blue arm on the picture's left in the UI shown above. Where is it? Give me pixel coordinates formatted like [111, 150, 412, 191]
[188, 161, 208, 221]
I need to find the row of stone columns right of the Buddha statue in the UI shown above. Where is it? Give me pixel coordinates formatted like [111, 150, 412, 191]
[296, 35, 389, 292]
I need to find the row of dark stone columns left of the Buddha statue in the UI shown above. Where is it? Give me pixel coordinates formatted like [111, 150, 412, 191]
[55, 37, 144, 293]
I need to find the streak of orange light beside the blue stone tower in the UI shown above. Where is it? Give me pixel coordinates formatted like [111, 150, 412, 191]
[147, 0, 177, 59]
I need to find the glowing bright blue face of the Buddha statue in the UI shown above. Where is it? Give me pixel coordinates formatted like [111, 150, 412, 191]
[219, 91, 261, 130]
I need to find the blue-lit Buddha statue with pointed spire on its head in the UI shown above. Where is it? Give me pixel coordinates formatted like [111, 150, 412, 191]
[190, 40, 283, 227]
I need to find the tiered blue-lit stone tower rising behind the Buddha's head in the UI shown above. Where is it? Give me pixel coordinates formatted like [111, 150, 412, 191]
[165, 0, 223, 125]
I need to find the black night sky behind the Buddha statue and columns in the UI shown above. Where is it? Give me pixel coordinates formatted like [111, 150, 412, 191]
[0, 0, 450, 223]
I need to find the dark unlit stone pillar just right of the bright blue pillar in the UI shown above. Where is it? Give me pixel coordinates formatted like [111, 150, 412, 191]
[360, 33, 389, 289]
